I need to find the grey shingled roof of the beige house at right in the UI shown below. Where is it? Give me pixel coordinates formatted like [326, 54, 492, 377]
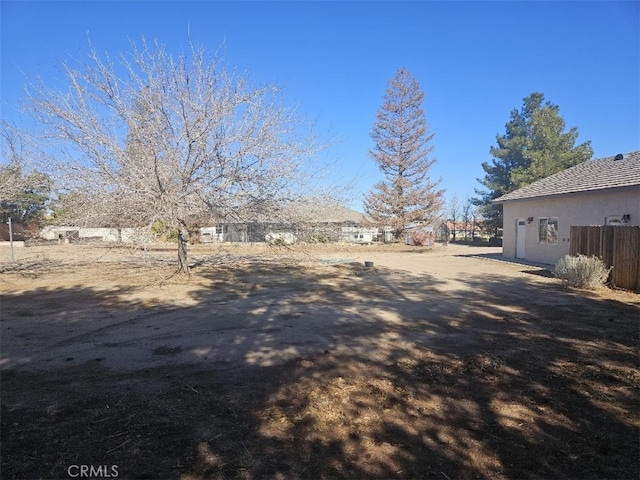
[493, 151, 640, 203]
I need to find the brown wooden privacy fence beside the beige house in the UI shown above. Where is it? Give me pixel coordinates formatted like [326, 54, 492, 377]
[569, 225, 640, 292]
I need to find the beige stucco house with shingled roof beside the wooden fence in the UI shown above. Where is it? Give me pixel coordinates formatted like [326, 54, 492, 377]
[494, 151, 640, 264]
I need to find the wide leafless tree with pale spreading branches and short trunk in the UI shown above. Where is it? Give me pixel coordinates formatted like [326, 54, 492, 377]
[27, 40, 319, 272]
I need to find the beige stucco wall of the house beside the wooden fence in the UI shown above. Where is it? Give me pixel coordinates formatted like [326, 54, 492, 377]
[502, 186, 640, 265]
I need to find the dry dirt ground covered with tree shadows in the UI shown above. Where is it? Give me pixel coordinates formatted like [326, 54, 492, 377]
[0, 245, 640, 480]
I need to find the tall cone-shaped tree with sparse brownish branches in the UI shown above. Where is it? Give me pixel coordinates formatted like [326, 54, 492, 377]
[364, 68, 443, 239]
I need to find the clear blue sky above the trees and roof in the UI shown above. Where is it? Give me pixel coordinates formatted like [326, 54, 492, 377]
[0, 0, 640, 209]
